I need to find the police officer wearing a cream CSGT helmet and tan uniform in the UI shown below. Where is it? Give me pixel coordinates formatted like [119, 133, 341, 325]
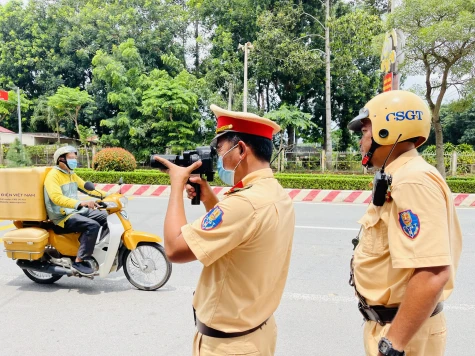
[348, 91, 462, 356]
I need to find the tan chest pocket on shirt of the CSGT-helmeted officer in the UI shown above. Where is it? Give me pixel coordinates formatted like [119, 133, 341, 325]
[358, 206, 388, 256]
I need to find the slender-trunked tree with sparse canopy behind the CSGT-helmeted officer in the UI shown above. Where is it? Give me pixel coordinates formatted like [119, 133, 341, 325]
[388, 0, 475, 177]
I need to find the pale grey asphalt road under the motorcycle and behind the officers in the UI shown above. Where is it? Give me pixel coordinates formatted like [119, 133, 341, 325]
[0, 198, 475, 356]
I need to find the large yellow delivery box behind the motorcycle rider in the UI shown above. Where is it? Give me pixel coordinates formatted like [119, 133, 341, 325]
[0, 167, 51, 221]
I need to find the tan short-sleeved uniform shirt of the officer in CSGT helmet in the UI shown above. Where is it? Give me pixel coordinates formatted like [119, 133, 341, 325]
[353, 149, 462, 305]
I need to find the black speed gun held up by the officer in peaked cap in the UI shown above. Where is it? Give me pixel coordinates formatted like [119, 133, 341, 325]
[150, 146, 216, 205]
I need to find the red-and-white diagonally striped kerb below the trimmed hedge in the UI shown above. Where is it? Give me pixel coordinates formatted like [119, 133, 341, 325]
[96, 184, 475, 207]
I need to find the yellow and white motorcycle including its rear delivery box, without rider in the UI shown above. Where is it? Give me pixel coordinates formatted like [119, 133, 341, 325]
[0, 168, 172, 290]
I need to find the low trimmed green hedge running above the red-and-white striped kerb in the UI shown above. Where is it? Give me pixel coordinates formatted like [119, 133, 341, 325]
[71, 169, 475, 193]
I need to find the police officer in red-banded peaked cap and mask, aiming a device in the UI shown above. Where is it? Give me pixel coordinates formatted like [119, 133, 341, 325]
[157, 105, 295, 356]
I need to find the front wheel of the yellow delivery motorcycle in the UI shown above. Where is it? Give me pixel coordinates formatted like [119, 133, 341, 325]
[123, 242, 172, 290]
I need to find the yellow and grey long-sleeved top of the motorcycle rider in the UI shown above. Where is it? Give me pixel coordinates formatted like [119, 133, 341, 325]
[44, 166, 108, 227]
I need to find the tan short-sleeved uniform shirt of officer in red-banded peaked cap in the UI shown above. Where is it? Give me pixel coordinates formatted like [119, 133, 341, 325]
[181, 169, 295, 332]
